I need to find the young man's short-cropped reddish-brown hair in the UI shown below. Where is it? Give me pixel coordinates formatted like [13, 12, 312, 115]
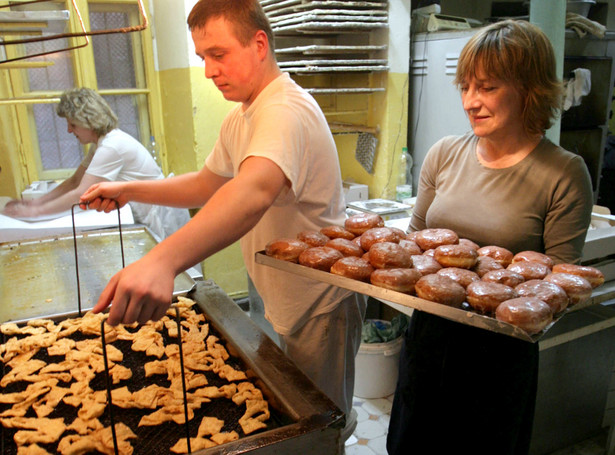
[188, 0, 275, 58]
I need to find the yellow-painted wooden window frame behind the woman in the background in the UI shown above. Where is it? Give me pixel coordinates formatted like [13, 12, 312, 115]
[0, 0, 166, 187]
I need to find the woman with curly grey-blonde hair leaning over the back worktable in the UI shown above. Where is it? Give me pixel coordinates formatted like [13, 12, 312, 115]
[3, 87, 189, 238]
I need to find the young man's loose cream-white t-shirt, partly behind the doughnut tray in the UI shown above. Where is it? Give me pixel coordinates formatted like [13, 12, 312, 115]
[205, 73, 350, 335]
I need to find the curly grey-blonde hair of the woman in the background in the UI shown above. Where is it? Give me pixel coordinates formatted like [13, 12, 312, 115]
[56, 87, 117, 137]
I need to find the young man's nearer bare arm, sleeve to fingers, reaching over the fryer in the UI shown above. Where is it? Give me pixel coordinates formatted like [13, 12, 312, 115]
[94, 157, 289, 325]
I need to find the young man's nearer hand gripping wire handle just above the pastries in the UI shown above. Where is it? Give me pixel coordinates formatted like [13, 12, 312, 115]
[92, 255, 175, 326]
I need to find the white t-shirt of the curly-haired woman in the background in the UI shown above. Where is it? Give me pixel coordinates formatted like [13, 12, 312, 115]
[81, 128, 164, 182]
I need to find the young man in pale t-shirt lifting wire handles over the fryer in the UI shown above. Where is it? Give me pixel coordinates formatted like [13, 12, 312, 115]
[81, 0, 365, 439]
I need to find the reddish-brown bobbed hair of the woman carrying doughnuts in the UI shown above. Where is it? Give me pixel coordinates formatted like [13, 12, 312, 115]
[454, 19, 563, 134]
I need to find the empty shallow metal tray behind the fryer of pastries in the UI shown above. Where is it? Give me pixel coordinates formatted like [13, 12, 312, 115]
[0, 227, 195, 322]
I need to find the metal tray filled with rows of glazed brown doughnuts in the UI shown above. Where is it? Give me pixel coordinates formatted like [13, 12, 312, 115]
[255, 213, 604, 342]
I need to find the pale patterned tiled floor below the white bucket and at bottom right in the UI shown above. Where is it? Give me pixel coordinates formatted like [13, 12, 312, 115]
[345, 395, 606, 455]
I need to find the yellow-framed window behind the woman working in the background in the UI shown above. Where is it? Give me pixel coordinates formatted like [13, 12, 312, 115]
[0, 0, 154, 180]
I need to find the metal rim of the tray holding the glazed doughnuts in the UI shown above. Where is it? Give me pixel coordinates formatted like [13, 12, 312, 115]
[255, 251, 602, 343]
